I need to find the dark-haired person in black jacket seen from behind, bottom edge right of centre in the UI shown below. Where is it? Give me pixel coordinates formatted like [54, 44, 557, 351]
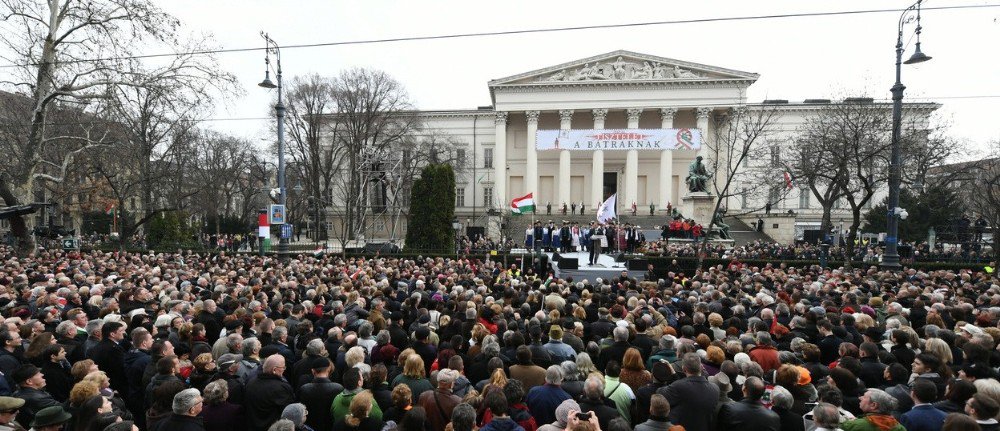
[656, 353, 720, 431]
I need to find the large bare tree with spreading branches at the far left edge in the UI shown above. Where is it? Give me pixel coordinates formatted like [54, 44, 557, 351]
[0, 0, 229, 253]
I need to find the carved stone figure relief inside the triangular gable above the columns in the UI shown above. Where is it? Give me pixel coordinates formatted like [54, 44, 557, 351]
[537, 57, 705, 82]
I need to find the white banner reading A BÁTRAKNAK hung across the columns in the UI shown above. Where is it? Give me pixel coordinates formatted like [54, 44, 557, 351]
[535, 129, 701, 151]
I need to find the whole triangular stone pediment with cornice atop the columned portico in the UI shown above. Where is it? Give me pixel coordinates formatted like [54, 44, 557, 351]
[489, 50, 759, 88]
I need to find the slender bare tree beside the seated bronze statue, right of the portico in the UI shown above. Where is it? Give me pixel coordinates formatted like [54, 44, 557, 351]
[698, 106, 779, 268]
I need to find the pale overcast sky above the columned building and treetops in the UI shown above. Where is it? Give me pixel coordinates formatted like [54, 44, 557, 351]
[158, 0, 1000, 155]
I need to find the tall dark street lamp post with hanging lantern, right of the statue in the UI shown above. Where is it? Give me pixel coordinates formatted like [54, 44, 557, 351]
[882, 0, 931, 269]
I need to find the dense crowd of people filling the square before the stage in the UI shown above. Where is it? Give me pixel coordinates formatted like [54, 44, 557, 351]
[0, 249, 1000, 431]
